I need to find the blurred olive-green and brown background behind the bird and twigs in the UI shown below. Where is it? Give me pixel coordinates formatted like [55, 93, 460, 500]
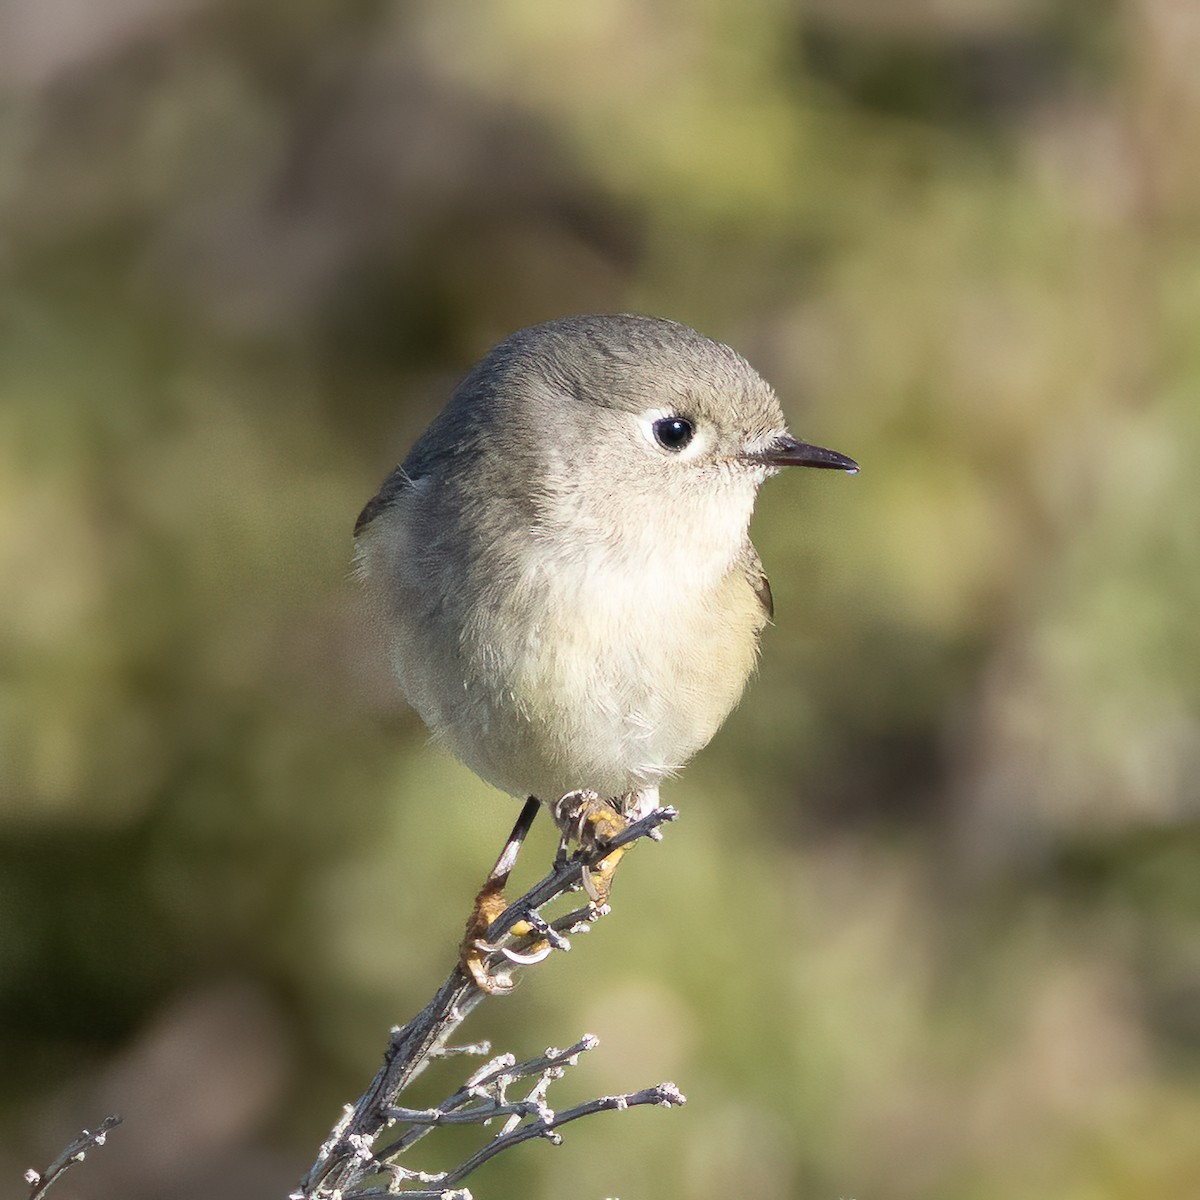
[0, 0, 1200, 1200]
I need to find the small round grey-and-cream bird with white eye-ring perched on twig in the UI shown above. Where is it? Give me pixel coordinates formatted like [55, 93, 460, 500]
[355, 314, 858, 984]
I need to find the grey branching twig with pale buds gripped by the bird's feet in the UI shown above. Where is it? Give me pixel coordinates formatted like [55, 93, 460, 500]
[295, 808, 683, 1200]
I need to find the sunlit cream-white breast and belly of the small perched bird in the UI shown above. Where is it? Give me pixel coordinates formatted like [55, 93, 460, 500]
[458, 523, 762, 794]
